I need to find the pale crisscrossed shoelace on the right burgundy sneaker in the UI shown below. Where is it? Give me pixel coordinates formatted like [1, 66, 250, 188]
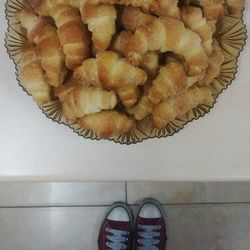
[137, 225, 161, 250]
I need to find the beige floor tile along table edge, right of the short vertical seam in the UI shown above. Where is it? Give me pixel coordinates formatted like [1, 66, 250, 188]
[127, 182, 250, 204]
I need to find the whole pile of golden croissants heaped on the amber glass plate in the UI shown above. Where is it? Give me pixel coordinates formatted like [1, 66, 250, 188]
[16, 0, 244, 138]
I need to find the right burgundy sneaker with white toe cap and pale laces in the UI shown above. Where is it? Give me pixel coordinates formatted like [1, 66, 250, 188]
[135, 199, 167, 250]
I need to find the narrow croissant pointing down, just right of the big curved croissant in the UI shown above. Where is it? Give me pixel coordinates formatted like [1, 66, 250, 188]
[181, 6, 213, 55]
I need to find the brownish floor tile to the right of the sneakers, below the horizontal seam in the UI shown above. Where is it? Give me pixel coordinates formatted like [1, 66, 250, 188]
[165, 204, 250, 250]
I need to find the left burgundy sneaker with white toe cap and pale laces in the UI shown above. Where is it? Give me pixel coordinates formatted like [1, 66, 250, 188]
[98, 203, 133, 250]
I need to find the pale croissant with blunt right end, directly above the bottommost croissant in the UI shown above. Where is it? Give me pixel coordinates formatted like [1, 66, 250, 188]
[63, 86, 117, 120]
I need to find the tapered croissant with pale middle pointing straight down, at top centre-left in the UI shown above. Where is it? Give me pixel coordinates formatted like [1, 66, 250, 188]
[81, 3, 117, 51]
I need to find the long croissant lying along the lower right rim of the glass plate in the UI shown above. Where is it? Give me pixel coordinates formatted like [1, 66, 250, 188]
[153, 86, 214, 128]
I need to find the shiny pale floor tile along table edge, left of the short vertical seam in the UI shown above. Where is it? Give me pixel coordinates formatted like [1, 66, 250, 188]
[0, 182, 125, 207]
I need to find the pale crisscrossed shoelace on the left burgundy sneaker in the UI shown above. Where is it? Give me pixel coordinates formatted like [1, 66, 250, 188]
[106, 228, 129, 250]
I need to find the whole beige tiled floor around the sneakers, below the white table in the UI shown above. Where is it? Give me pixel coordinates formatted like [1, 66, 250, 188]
[0, 182, 250, 250]
